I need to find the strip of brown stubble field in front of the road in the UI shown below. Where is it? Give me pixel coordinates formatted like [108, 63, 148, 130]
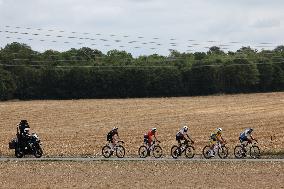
[0, 161, 284, 189]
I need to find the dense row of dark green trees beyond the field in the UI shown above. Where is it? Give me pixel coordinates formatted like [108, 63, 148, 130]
[0, 42, 284, 100]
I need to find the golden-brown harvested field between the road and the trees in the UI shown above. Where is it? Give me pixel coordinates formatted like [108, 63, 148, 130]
[0, 93, 284, 156]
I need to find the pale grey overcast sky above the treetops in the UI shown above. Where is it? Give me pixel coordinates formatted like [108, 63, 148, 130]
[0, 0, 284, 56]
